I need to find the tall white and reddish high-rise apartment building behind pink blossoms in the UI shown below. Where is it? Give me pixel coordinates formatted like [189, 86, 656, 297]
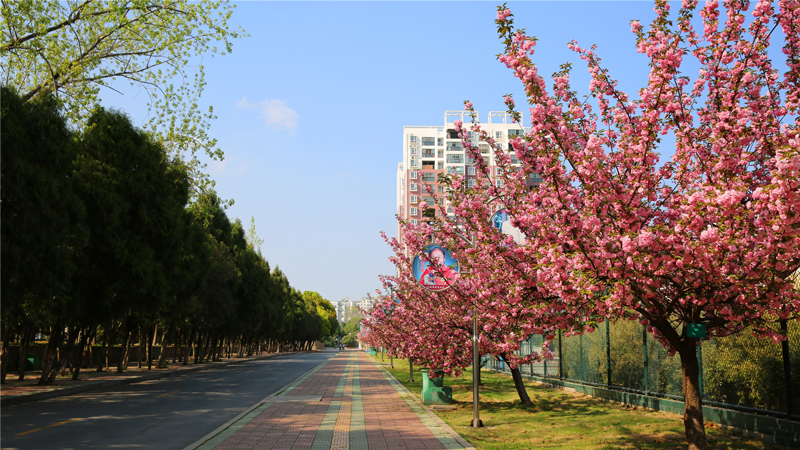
[397, 111, 538, 229]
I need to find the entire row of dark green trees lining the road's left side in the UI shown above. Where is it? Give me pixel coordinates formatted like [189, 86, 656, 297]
[2, 87, 338, 384]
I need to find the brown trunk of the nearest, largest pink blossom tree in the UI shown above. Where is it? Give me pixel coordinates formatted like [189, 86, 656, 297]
[678, 338, 708, 450]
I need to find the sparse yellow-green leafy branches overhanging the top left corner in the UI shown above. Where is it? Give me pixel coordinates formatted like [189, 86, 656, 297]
[0, 0, 244, 162]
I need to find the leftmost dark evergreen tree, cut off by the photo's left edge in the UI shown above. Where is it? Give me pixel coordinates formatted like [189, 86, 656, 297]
[0, 87, 86, 380]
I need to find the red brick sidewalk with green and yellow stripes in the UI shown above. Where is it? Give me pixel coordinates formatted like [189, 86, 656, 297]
[187, 350, 472, 450]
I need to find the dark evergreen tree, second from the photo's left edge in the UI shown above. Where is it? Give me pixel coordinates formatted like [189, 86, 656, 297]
[69, 108, 189, 376]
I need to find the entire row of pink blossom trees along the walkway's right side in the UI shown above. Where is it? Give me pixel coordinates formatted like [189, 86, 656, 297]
[363, 0, 800, 449]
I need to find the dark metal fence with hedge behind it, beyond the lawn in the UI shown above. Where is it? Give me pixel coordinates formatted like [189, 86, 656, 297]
[486, 321, 800, 420]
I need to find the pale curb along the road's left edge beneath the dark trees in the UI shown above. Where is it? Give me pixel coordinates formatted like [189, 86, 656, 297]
[0, 352, 297, 408]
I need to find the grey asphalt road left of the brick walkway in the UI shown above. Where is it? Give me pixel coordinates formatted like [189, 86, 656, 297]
[0, 351, 336, 450]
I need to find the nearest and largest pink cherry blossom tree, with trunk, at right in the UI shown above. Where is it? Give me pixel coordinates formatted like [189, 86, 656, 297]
[457, 0, 800, 449]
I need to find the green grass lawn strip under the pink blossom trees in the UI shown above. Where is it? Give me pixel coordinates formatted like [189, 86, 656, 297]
[377, 354, 785, 450]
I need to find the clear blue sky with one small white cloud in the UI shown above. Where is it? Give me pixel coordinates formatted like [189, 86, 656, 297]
[97, 1, 678, 301]
